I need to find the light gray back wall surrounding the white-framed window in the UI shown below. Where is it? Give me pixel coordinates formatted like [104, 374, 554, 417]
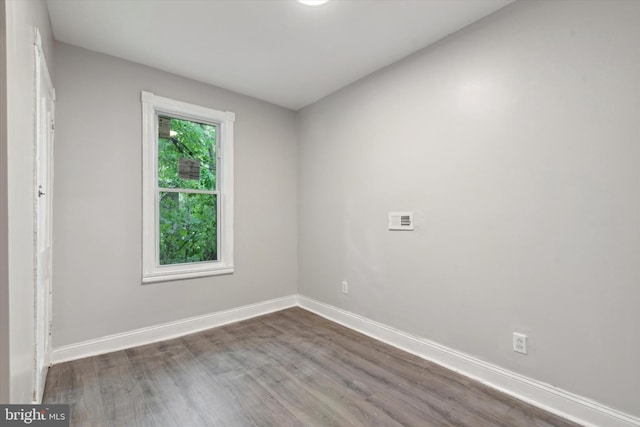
[53, 44, 297, 347]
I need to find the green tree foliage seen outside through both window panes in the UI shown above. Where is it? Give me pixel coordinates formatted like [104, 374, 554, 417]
[158, 118, 218, 265]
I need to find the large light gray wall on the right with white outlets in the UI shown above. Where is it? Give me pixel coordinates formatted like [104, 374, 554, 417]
[298, 1, 640, 416]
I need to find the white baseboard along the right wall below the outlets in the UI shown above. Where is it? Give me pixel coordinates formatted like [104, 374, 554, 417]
[297, 295, 640, 427]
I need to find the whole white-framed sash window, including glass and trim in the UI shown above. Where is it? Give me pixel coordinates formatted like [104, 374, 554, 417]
[142, 91, 235, 283]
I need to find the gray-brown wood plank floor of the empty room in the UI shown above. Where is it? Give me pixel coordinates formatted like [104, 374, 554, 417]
[44, 308, 576, 427]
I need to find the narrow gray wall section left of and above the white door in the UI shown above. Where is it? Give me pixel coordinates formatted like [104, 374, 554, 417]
[6, 0, 54, 403]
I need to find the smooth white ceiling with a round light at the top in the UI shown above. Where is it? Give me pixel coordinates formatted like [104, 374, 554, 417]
[47, 0, 513, 110]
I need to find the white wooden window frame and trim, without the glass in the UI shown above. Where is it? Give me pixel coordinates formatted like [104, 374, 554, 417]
[141, 91, 235, 283]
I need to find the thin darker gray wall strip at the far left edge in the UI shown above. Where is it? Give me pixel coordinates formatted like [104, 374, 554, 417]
[0, 0, 10, 403]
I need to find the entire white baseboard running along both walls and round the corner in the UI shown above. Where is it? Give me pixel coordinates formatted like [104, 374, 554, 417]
[51, 295, 640, 427]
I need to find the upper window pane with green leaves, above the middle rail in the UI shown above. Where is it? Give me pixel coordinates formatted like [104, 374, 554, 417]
[158, 116, 216, 190]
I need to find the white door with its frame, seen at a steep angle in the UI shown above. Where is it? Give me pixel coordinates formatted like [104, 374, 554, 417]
[33, 32, 55, 403]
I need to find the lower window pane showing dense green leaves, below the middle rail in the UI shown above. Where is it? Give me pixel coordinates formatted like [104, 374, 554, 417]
[160, 192, 218, 265]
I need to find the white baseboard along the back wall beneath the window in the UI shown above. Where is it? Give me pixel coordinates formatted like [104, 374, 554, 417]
[51, 295, 297, 365]
